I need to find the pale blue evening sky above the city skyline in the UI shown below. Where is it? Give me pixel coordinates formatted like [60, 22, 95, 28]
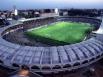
[0, 0, 103, 10]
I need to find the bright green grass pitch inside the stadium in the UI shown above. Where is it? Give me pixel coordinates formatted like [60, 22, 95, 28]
[26, 22, 93, 44]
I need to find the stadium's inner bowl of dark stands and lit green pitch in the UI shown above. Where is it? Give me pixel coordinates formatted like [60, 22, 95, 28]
[3, 17, 100, 46]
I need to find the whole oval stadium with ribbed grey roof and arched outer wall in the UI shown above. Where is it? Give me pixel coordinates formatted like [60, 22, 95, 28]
[0, 13, 103, 77]
